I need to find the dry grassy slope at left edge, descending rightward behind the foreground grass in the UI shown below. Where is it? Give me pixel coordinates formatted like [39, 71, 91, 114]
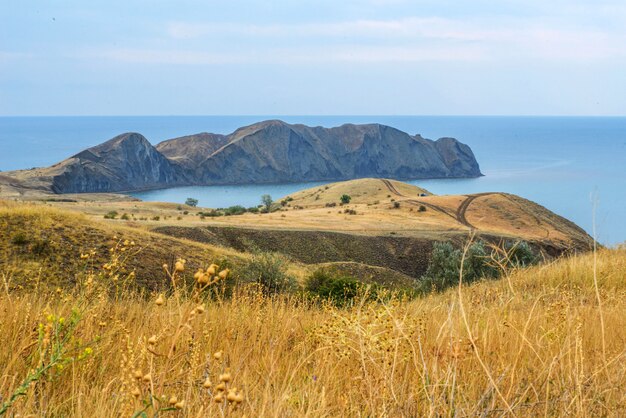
[0, 201, 246, 289]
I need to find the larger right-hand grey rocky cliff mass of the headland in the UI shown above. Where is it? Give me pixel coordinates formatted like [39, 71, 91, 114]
[194, 121, 481, 184]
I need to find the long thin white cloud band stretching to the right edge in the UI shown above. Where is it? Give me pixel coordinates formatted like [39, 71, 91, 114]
[167, 17, 626, 61]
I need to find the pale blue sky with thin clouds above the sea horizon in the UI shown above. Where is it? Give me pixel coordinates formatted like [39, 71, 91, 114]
[0, 0, 626, 116]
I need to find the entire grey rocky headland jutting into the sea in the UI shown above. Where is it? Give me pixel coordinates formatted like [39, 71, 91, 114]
[6, 121, 481, 193]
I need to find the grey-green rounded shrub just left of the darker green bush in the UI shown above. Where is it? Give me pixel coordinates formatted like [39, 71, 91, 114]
[241, 252, 297, 295]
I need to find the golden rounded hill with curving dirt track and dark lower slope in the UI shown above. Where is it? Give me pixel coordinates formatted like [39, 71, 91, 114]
[152, 179, 593, 277]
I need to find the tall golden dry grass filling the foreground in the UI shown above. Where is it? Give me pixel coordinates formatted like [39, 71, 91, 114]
[0, 235, 626, 417]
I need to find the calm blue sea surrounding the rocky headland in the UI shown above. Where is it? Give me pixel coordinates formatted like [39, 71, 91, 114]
[0, 116, 626, 245]
